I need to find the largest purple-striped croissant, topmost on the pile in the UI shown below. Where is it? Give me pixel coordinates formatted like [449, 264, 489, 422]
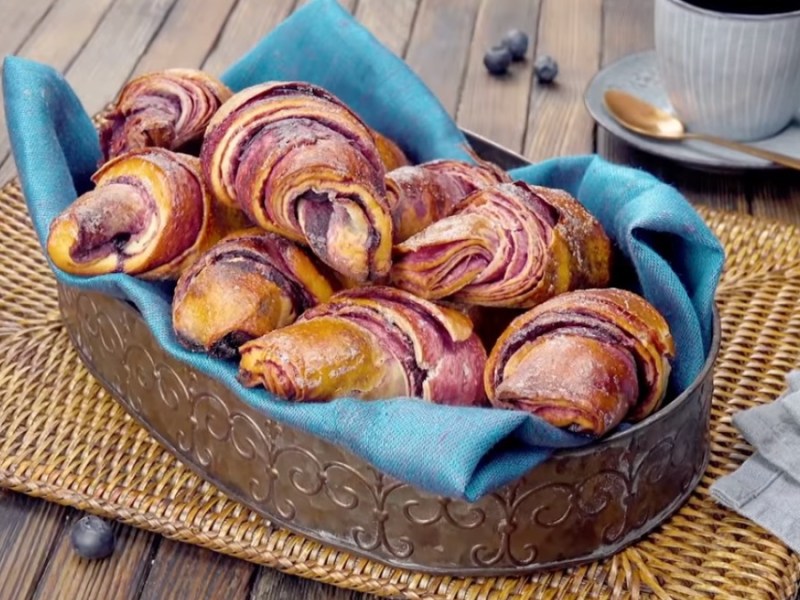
[201, 82, 392, 282]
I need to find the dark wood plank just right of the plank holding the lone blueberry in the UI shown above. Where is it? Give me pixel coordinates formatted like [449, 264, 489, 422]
[138, 540, 253, 600]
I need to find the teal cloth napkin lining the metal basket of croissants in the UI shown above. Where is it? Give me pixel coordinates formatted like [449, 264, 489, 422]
[3, 0, 724, 500]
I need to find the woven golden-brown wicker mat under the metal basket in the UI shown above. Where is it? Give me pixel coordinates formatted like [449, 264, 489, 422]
[0, 176, 800, 600]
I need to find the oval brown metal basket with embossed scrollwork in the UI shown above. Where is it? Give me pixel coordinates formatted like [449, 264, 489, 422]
[59, 134, 720, 576]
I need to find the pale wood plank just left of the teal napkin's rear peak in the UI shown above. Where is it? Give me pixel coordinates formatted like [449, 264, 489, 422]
[203, 0, 295, 75]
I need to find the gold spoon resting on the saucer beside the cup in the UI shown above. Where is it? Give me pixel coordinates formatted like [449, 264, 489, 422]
[603, 90, 800, 170]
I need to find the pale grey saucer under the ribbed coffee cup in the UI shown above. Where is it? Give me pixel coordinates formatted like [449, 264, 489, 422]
[584, 50, 800, 170]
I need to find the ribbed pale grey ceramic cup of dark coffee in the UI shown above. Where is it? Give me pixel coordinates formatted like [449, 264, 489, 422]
[655, 0, 800, 141]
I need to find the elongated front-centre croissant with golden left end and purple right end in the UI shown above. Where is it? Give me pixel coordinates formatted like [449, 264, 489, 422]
[239, 286, 486, 405]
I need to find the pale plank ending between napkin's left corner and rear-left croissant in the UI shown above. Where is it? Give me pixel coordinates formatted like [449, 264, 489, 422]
[66, 0, 175, 114]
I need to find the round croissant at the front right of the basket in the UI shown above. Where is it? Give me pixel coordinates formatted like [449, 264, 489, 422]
[484, 288, 675, 436]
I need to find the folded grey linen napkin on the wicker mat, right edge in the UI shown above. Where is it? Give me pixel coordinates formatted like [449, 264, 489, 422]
[711, 371, 800, 552]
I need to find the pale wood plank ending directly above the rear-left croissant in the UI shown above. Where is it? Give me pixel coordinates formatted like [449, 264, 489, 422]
[134, 0, 236, 75]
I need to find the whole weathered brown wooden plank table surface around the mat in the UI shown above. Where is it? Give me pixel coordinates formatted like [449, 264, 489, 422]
[0, 0, 800, 600]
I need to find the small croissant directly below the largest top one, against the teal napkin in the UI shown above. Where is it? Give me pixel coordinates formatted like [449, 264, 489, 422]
[172, 229, 333, 358]
